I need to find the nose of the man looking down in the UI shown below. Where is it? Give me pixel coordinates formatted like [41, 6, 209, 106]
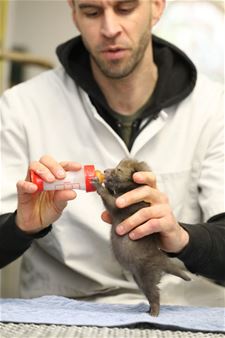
[101, 12, 121, 39]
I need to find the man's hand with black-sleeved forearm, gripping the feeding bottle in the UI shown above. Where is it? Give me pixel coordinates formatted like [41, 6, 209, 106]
[0, 155, 81, 268]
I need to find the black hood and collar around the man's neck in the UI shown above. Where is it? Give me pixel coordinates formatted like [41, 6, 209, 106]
[57, 36, 197, 149]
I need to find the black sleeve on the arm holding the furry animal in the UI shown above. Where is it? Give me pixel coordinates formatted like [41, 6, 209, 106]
[169, 214, 225, 285]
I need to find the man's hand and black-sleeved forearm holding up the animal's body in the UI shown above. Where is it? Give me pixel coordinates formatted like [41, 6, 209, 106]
[107, 172, 225, 282]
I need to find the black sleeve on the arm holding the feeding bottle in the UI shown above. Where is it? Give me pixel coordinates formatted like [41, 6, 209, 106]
[0, 212, 52, 269]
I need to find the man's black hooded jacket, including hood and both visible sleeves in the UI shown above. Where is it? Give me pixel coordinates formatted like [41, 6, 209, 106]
[0, 36, 225, 284]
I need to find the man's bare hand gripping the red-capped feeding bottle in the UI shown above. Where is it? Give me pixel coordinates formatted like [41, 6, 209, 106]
[16, 155, 81, 233]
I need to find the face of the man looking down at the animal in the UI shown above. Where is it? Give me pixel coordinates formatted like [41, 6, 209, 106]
[74, 0, 156, 79]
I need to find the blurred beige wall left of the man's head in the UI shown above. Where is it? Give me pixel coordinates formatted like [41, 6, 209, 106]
[0, 0, 78, 88]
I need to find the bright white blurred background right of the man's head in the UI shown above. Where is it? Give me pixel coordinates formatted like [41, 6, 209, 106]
[155, 0, 225, 82]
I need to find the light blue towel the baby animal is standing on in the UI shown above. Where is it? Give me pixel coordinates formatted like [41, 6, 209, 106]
[0, 296, 225, 333]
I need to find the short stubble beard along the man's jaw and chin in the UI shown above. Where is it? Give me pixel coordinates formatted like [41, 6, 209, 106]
[84, 32, 150, 80]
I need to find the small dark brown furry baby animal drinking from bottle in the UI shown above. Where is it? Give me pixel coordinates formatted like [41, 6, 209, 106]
[94, 159, 190, 316]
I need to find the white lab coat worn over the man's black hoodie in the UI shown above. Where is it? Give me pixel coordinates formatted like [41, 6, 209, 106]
[0, 67, 225, 306]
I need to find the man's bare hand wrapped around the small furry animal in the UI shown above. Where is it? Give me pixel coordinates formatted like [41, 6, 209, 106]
[102, 172, 189, 253]
